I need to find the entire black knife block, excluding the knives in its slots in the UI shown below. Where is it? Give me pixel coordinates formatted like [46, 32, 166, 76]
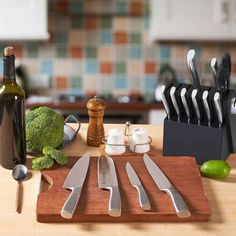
[163, 83, 236, 164]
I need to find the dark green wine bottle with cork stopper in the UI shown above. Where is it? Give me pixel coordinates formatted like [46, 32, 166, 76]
[0, 47, 26, 169]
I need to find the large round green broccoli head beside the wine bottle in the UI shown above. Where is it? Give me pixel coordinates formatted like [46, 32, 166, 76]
[26, 107, 64, 152]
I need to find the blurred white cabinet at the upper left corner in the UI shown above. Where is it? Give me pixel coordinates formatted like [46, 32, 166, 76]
[0, 0, 49, 40]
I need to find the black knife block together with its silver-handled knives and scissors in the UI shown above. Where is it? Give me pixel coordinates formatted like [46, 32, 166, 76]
[161, 50, 236, 164]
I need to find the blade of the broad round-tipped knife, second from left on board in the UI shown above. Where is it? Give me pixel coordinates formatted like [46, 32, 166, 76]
[98, 156, 118, 188]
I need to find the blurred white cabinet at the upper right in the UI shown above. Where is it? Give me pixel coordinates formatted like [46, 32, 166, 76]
[150, 0, 236, 41]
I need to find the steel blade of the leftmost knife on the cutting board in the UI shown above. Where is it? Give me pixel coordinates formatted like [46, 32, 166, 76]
[63, 153, 90, 189]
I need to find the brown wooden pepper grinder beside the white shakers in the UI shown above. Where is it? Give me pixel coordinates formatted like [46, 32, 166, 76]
[87, 97, 105, 147]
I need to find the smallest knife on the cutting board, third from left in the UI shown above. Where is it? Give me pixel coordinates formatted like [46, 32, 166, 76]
[126, 162, 151, 211]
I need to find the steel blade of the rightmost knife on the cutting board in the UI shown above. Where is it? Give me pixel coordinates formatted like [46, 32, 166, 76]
[143, 153, 172, 190]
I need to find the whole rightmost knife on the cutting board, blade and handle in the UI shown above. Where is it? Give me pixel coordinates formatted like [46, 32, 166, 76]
[143, 153, 190, 218]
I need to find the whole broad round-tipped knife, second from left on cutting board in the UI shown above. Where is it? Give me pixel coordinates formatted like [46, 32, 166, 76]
[98, 156, 121, 217]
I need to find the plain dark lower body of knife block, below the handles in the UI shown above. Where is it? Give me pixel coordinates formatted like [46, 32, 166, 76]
[163, 118, 230, 164]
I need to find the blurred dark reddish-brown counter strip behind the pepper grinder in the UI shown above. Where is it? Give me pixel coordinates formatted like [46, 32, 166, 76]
[26, 102, 163, 111]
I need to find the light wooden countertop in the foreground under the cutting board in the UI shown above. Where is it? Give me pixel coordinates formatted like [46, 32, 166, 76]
[0, 124, 236, 236]
